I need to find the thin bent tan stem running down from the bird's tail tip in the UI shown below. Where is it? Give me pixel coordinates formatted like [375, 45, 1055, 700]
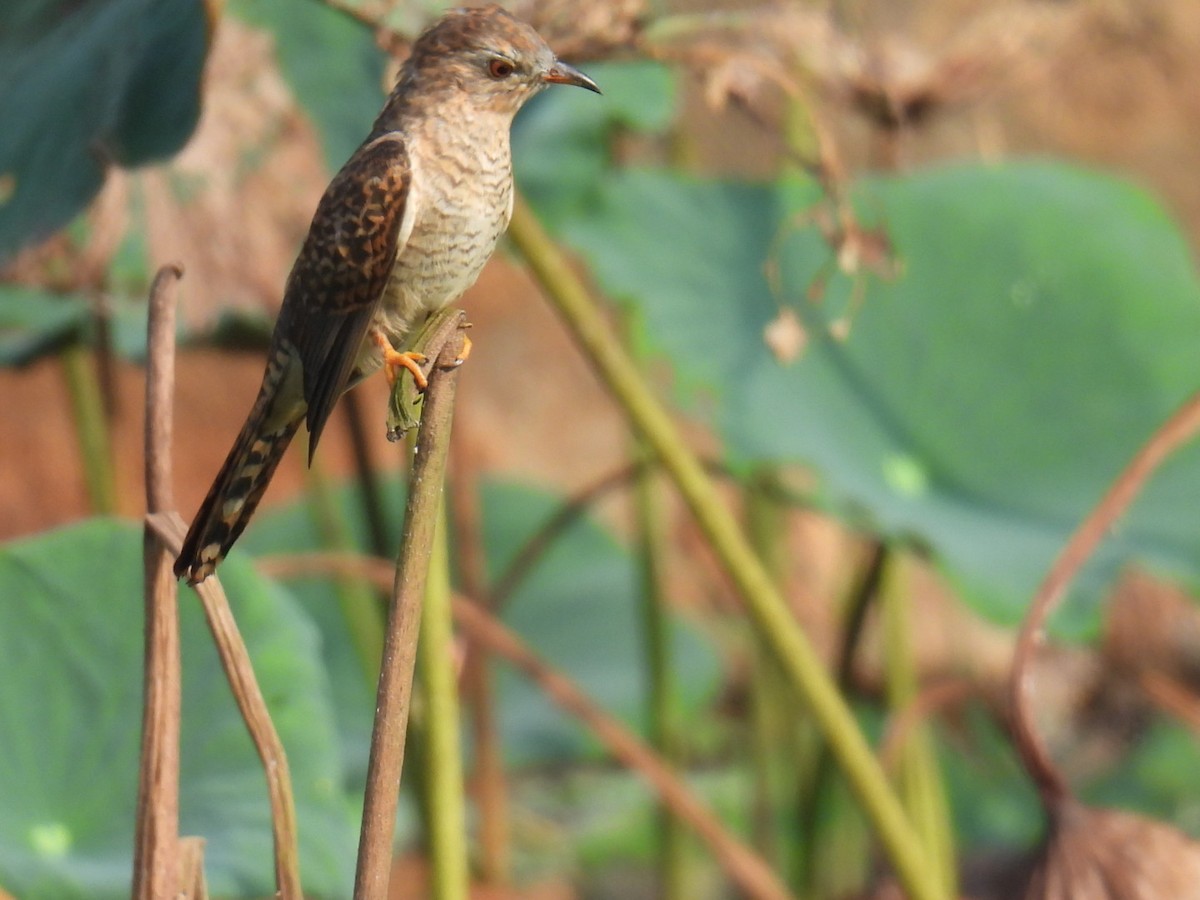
[146, 512, 302, 900]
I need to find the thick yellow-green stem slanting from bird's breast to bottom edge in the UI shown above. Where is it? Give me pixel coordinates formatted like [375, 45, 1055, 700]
[509, 198, 944, 900]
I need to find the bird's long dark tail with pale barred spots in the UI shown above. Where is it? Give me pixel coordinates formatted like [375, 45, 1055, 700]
[175, 384, 304, 584]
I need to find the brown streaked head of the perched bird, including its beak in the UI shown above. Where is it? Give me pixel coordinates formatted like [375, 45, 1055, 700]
[401, 5, 600, 115]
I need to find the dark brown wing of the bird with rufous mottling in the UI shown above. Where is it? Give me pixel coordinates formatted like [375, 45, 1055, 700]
[276, 134, 412, 460]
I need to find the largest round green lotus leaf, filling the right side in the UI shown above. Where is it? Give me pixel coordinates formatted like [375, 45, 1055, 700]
[564, 163, 1200, 628]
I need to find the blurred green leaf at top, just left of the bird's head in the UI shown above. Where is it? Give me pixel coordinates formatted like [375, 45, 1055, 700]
[229, 0, 386, 169]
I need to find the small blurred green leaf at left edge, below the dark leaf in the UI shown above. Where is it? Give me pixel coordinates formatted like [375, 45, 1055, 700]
[0, 286, 91, 366]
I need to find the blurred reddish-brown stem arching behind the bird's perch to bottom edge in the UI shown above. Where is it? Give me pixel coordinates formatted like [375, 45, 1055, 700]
[259, 553, 791, 900]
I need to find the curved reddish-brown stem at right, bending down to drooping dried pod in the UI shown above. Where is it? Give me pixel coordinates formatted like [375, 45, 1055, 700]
[1009, 394, 1200, 810]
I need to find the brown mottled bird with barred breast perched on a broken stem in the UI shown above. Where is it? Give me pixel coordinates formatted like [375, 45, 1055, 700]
[174, 5, 600, 584]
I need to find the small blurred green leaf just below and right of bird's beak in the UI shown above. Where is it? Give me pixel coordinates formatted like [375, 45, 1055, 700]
[512, 61, 676, 222]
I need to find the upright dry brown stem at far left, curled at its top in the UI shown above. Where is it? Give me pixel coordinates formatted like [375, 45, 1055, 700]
[132, 264, 184, 900]
